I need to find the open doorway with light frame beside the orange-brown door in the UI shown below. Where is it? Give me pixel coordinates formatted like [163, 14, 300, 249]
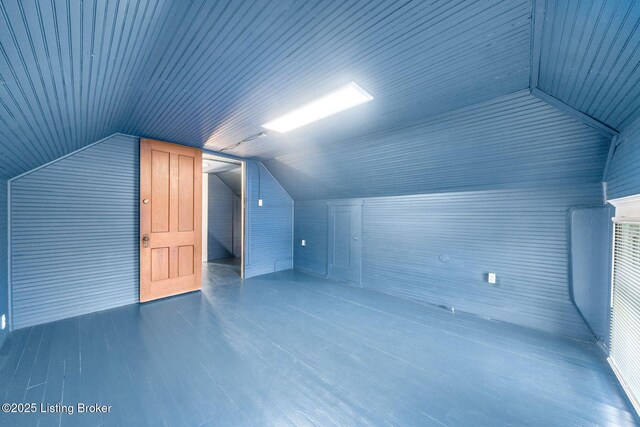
[202, 154, 245, 277]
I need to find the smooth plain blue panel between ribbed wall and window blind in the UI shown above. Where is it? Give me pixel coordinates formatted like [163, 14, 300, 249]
[570, 205, 614, 344]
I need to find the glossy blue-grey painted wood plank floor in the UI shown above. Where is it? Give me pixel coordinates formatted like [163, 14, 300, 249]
[0, 264, 637, 426]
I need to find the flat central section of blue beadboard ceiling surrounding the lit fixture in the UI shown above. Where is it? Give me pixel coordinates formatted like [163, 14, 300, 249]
[124, 0, 531, 158]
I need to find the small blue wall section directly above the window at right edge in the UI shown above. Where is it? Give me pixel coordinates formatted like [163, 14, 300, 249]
[606, 119, 640, 200]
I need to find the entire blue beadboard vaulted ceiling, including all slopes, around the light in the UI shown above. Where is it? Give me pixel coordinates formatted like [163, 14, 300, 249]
[0, 0, 640, 198]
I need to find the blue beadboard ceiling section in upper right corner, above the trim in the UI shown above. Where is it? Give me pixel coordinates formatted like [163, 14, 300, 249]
[536, 0, 640, 131]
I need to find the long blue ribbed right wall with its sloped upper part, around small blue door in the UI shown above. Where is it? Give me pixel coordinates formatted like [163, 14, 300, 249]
[265, 91, 610, 338]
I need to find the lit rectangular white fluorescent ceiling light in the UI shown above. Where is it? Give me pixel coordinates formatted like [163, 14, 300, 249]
[262, 82, 373, 133]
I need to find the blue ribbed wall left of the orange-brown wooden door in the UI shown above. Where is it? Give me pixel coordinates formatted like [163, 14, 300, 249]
[11, 135, 139, 328]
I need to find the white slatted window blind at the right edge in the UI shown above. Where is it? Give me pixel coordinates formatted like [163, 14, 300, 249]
[610, 222, 640, 412]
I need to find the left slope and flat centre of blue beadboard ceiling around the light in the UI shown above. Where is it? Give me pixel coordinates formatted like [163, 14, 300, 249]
[0, 0, 531, 177]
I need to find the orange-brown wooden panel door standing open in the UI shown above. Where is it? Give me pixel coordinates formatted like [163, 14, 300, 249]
[140, 139, 202, 302]
